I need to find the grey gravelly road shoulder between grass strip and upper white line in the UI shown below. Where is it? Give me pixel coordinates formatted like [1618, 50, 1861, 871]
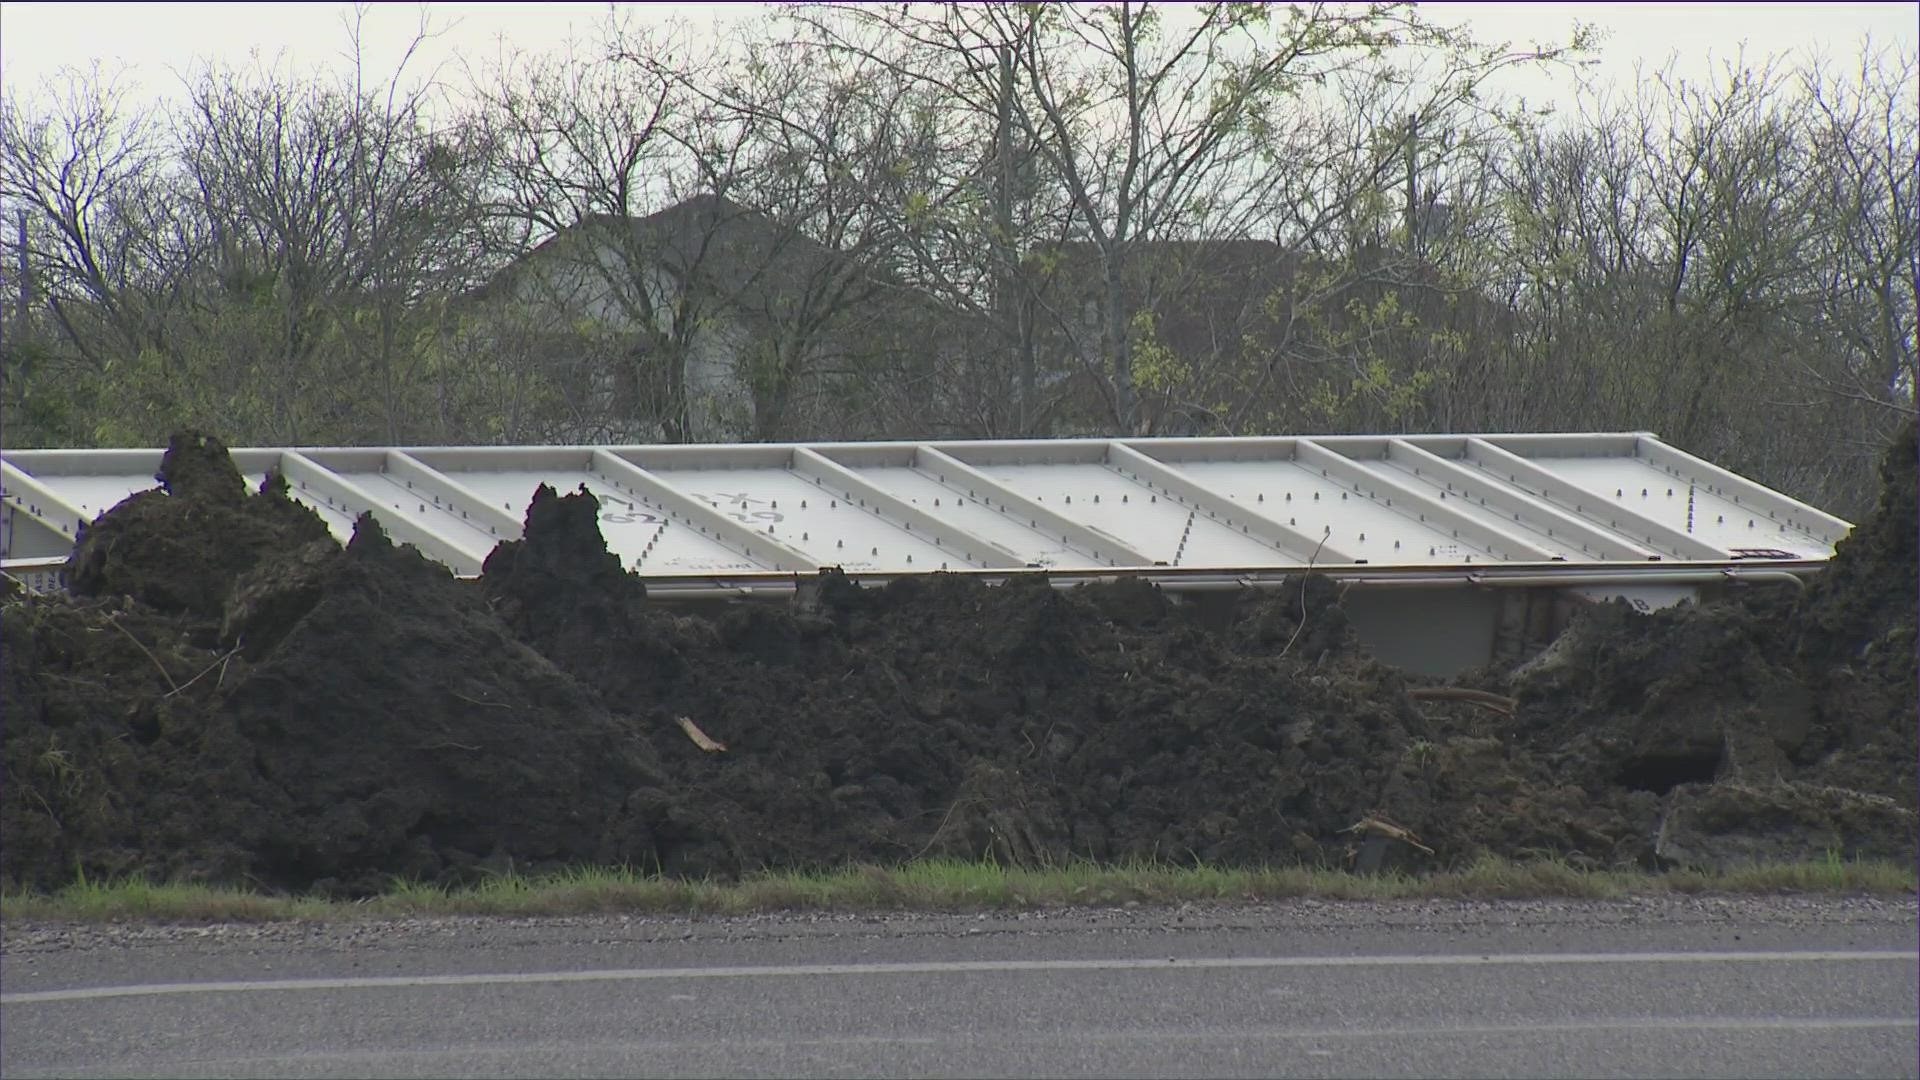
[0, 896, 1920, 990]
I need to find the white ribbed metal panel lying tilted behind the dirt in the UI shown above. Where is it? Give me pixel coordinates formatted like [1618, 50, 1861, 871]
[0, 432, 1851, 580]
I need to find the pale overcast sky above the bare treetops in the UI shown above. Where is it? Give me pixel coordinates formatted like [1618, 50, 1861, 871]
[0, 2, 1920, 102]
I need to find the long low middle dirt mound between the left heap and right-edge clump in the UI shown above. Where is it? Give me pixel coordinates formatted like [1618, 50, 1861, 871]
[480, 492, 1657, 872]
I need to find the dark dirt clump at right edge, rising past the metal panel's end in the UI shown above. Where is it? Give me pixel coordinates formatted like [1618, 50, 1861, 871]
[1480, 430, 1920, 867]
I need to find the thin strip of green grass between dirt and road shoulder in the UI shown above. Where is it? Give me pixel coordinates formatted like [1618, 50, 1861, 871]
[0, 857, 1920, 922]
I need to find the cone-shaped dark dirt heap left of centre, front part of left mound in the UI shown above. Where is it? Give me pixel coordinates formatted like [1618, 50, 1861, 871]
[219, 517, 660, 888]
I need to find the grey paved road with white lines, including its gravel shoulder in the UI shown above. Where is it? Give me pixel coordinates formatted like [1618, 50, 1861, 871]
[0, 899, 1920, 1076]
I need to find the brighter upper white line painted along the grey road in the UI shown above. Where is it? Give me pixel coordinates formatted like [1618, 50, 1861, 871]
[0, 949, 1920, 1005]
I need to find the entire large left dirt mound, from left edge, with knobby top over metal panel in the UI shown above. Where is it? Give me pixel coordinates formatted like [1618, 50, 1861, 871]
[0, 440, 662, 892]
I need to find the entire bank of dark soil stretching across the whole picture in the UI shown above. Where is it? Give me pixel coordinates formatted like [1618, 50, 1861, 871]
[0, 434, 1916, 892]
